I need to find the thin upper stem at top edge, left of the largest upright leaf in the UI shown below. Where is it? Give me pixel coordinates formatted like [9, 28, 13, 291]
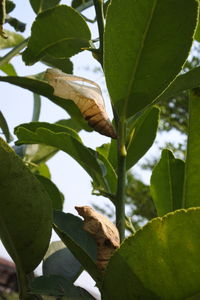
[93, 0, 104, 67]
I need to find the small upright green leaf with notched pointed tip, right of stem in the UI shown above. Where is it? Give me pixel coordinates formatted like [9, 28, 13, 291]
[150, 149, 185, 216]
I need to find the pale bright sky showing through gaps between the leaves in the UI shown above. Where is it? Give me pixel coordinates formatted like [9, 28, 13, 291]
[0, 0, 186, 298]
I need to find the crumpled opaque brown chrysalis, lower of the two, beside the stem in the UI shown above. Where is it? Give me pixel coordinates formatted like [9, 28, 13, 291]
[75, 206, 120, 271]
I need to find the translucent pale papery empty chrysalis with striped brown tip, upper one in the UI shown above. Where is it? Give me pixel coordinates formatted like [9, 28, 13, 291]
[45, 69, 117, 139]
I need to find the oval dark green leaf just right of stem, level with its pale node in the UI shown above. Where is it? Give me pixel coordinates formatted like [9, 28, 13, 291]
[126, 107, 160, 170]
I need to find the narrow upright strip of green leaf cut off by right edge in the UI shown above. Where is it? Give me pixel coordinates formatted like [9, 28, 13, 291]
[184, 89, 200, 208]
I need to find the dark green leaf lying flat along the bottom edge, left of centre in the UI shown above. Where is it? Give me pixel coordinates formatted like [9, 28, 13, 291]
[30, 275, 95, 300]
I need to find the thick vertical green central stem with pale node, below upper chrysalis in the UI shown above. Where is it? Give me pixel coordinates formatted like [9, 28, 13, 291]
[116, 120, 127, 241]
